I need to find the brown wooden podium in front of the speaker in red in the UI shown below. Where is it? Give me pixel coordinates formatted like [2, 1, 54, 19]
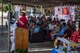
[15, 27, 29, 49]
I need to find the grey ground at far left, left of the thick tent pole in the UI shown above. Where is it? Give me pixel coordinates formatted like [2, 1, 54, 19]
[0, 26, 8, 53]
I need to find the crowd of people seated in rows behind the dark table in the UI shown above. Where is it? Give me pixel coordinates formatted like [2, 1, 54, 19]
[28, 16, 79, 42]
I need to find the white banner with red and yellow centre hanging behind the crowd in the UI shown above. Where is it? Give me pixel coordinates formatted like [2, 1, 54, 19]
[54, 6, 75, 22]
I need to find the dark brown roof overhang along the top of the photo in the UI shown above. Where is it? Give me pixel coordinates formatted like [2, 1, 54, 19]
[4, 0, 80, 5]
